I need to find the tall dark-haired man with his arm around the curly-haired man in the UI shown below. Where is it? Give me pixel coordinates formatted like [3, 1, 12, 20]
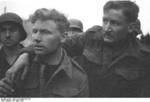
[2, 1, 150, 97]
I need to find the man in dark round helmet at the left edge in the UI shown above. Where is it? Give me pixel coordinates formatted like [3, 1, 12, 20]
[0, 13, 26, 79]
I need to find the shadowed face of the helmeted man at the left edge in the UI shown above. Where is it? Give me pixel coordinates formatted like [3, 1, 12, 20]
[0, 22, 21, 47]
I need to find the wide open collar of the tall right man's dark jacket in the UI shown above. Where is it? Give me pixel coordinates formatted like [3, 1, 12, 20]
[83, 36, 140, 64]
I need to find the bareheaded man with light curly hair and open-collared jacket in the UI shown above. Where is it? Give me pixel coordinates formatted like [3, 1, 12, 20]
[0, 8, 88, 97]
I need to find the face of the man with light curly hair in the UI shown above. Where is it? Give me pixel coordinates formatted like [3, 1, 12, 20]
[32, 20, 61, 55]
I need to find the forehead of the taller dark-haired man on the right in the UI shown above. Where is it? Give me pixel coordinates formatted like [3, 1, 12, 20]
[104, 9, 126, 21]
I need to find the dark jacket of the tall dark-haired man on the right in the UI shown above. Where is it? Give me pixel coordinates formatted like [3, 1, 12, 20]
[64, 26, 150, 97]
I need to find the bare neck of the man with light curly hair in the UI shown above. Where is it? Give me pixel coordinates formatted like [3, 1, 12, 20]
[42, 48, 62, 65]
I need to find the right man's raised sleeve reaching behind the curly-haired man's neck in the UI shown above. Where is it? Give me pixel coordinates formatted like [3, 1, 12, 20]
[63, 25, 103, 57]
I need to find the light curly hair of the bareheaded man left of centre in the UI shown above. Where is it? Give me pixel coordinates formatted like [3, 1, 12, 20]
[31, 8, 69, 33]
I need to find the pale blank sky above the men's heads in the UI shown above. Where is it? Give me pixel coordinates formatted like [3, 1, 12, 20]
[0, 0, 150, 34]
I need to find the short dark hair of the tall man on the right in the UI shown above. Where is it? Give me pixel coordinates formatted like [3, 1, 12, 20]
[103, 0, 139, 23]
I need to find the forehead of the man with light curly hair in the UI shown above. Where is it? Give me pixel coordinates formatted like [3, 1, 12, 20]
[33, 20, 57, 30]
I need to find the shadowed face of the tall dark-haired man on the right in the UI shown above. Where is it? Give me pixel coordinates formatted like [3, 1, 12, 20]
[103, 9, 129, 43]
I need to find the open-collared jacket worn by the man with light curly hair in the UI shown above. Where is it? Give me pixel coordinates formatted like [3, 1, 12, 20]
[16, 49, 89, 97]
